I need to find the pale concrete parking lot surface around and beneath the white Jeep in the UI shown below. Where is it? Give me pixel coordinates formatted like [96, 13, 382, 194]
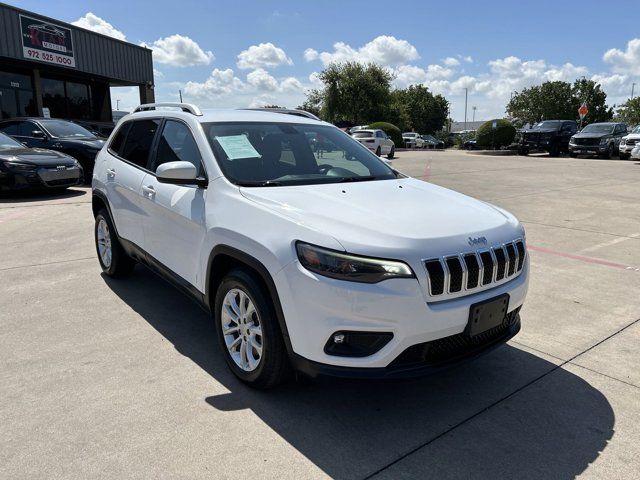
[0, 151, 640, 479]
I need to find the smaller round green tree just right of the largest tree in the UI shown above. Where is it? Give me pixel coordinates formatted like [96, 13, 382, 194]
[391, 85, 449, 133]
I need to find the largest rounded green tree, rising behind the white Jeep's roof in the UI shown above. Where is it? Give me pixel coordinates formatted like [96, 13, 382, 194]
[303, 62, 393, 125]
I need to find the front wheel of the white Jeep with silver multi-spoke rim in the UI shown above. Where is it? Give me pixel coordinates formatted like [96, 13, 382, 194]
[214, 269, 291, 389]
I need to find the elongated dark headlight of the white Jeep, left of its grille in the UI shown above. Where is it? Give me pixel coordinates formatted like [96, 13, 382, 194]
[296, 242, 414, 283]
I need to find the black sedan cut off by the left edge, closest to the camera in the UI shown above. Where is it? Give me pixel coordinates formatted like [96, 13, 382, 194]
[0, 133, 83, 192]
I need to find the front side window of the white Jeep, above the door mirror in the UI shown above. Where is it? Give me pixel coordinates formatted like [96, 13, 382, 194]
[152, 120, 203, 176]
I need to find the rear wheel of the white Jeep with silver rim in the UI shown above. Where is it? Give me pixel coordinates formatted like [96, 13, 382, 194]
[93, 210, 136, 278]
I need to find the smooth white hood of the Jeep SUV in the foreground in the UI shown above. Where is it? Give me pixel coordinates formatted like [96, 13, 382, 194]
[240, 178, 522, 258]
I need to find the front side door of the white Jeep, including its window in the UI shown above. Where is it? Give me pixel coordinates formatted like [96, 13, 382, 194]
[142, 119, 207, 287]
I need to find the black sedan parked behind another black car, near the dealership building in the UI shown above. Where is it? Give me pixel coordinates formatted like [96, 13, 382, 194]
[0, 118, 104, 182]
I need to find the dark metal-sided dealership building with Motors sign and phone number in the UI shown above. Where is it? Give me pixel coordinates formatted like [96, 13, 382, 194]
[0, 3, 154, 122]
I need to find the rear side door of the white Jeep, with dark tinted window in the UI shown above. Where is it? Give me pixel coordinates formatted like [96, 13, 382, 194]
[105, 118, 160, 249]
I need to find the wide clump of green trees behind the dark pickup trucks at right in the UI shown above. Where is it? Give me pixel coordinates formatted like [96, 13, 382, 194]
[507, 79, 613, 125]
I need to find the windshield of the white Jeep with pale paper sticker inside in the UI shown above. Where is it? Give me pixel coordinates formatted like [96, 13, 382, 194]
[202, 122, 397, 187]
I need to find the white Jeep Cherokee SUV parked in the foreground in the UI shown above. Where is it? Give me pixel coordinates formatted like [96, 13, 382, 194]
[93, 104, 529, 388]
